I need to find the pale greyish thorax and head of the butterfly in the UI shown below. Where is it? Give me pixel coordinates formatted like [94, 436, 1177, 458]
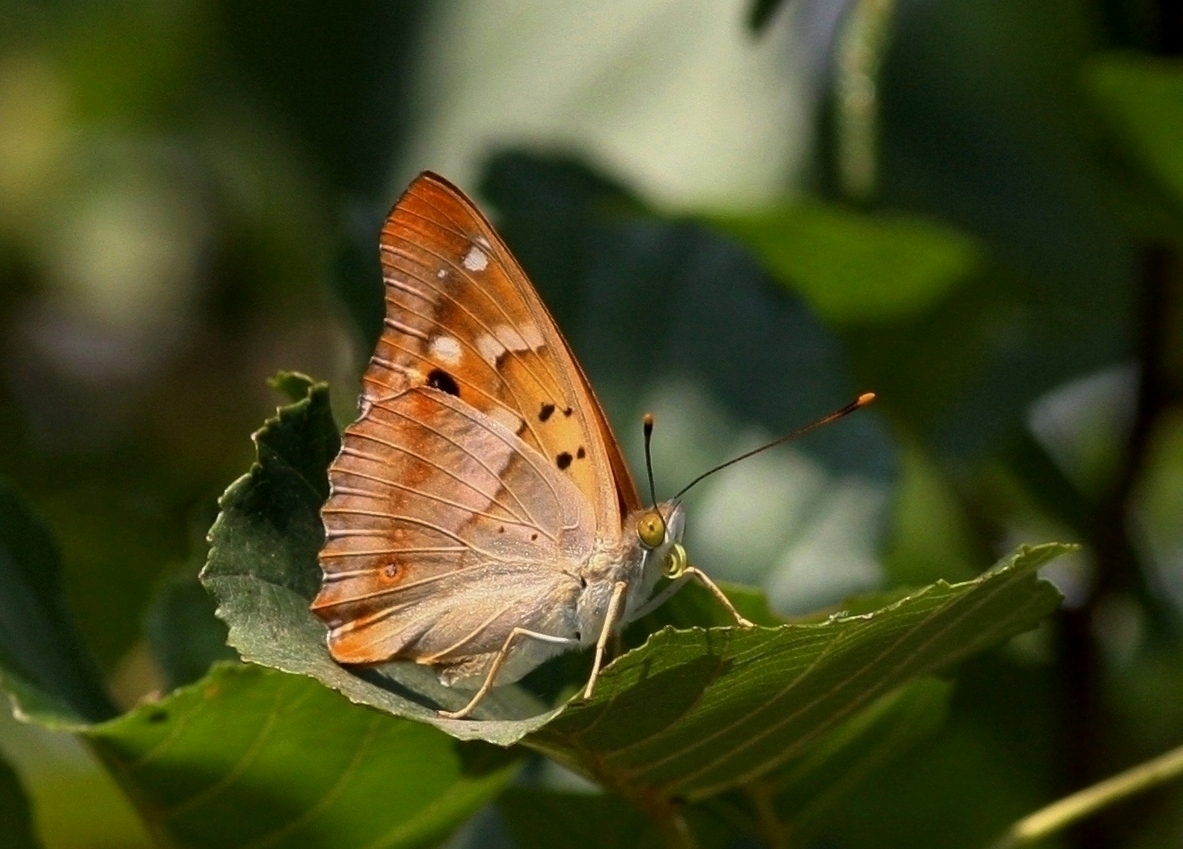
[576, 501, 685, 644]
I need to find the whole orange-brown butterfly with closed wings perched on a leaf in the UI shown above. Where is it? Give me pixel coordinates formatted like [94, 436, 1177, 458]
[311, 173, 865, 719]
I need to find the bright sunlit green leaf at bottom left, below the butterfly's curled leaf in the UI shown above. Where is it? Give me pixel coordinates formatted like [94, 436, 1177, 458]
[80, 663, 516, 848]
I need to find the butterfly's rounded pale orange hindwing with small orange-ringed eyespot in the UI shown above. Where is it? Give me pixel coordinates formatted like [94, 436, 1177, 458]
[313, 387, 593, 663]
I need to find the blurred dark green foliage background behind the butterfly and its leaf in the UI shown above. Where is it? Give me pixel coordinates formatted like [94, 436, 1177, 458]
[0, 0, 1183, 849]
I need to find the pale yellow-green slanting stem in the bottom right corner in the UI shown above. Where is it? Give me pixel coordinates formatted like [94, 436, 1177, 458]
[990, 746, 1183, 849]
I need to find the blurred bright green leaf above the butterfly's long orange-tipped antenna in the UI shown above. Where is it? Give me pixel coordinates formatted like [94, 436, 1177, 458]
[712, 202, 983, 324]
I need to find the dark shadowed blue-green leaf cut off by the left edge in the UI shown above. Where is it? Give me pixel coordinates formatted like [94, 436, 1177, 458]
[0, 480, 118, 724]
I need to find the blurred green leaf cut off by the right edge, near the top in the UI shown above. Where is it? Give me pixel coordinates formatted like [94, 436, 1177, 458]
[1085, 53, 1183, 227]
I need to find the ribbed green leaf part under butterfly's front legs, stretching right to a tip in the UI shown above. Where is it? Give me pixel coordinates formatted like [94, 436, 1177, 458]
[526, 544, 1068, 801]
